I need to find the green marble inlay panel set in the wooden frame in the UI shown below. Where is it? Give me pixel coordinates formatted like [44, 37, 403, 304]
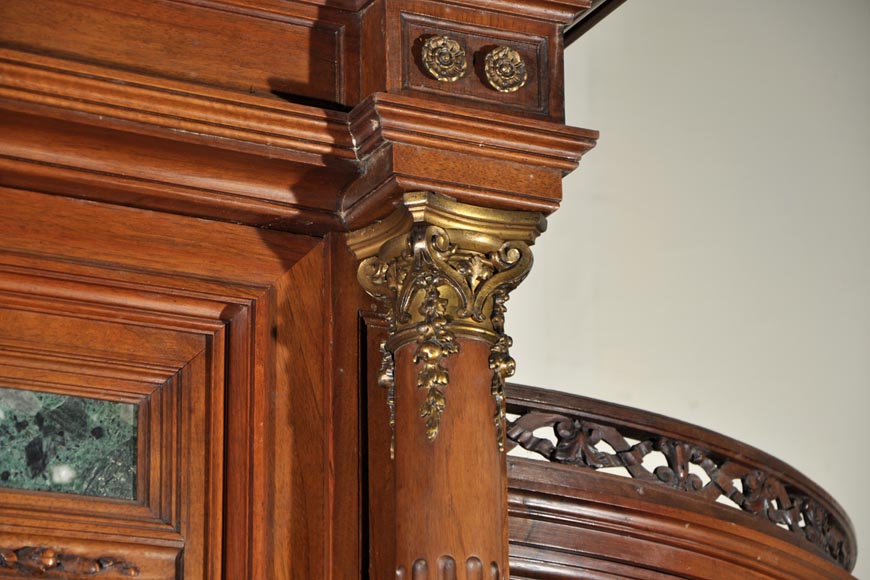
[0, 388, 136, 499]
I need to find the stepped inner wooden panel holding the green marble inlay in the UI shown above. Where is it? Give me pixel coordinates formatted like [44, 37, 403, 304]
[0, 302, 223, 578]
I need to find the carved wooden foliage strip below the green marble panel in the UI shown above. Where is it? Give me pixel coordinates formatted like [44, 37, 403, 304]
[0, 546, 139, 578]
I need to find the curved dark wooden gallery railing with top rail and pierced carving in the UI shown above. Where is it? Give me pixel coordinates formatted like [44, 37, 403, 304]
[507, 385, 856, 577]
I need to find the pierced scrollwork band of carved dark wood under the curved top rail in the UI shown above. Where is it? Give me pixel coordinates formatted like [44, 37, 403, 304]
[507, 402, 854, 569]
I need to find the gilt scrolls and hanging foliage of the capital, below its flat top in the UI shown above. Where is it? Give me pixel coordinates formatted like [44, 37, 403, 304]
[358, 223, 532, 448]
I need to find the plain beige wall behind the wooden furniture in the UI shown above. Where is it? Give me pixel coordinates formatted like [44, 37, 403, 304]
[507, 0, 870, 579]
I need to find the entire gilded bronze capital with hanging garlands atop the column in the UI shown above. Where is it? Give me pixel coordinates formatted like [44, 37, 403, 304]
[350, 193, 545, 448]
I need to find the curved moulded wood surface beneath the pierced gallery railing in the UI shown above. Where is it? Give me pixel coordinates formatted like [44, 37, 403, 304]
[509, 459, 852, 580]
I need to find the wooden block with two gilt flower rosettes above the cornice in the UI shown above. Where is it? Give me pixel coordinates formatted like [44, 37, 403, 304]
[378, 0, 584, 122]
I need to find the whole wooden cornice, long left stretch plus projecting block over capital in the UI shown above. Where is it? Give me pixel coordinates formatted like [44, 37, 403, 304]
[0, 49, 597, 234]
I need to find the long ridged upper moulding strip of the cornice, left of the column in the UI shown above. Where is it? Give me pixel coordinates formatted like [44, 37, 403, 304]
[0, 48, 356, 164]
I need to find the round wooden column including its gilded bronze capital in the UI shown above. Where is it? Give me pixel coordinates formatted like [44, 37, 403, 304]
[350, 193, 545, 580]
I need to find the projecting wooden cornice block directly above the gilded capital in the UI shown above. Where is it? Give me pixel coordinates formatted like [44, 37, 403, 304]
[341, 93, 598, 229]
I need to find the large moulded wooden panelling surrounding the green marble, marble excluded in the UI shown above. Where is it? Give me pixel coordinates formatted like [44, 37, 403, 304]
[0, 189, 359, 579]
